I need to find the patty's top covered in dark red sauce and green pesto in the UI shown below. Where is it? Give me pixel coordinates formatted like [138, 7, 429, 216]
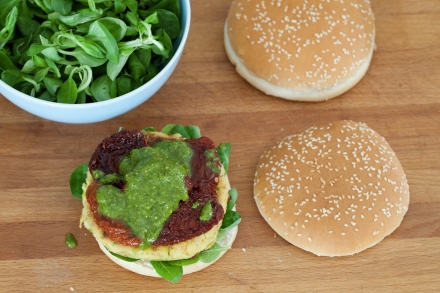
[86, 130, 224, 247]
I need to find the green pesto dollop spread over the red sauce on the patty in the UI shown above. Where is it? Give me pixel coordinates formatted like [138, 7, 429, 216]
[96, 140, 193, 248]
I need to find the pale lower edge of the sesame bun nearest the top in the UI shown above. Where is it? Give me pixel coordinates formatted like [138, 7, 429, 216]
[224, 22, 374, 102]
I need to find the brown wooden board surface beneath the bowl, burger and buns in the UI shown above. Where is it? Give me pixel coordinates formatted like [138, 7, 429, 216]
[0, 0, 440, 292]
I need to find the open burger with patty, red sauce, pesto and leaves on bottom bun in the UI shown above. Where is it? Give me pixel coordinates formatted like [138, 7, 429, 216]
[71, 125, 241, 282]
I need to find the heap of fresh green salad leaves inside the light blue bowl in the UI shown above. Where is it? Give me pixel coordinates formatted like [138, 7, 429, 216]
[0, 0, 180, 102]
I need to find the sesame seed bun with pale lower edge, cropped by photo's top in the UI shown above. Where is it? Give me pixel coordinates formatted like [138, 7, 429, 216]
[224, 0, 375, 101]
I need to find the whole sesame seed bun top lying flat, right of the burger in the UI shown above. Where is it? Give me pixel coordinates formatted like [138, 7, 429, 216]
[254, 121, 409, 256]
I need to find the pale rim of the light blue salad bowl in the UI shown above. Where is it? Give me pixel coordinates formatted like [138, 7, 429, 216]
[0, 0, 191, 110]
